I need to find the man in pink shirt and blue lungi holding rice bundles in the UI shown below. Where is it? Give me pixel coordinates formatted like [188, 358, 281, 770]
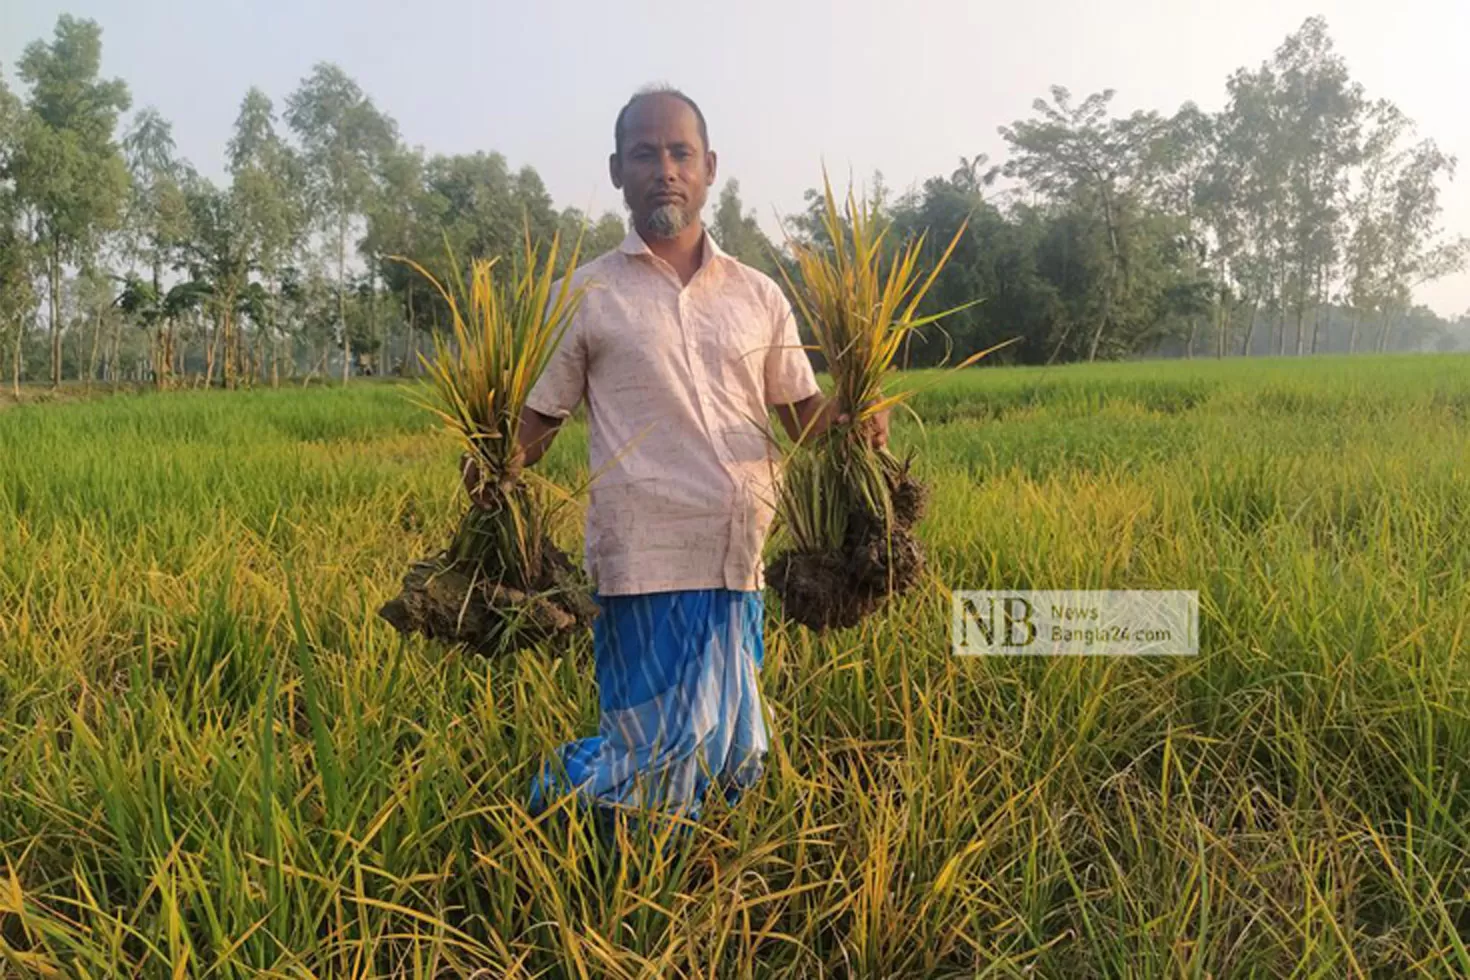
[466, 88, 888, 834]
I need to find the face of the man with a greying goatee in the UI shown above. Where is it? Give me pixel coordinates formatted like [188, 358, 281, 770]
[609, 96, 716, 238]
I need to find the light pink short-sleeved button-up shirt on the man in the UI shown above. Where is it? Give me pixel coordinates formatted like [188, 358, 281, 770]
[526, 231, 820, 595]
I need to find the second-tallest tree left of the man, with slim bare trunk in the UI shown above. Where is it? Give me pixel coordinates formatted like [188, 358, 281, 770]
[285, 63, 397, 382]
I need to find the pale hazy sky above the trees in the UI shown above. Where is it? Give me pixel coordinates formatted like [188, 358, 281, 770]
[0, 0, 1470, 314]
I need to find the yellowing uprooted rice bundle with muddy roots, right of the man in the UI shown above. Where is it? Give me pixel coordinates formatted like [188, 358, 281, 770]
[766, 178, 994, 630]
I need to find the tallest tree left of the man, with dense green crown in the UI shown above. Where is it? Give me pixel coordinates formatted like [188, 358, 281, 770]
[12, 13, 129, 385]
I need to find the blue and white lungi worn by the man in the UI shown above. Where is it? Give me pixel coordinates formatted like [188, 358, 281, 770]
[531, 589, 767, 818]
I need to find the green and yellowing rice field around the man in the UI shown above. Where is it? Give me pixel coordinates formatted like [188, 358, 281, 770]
[0, 356, 1470, 979]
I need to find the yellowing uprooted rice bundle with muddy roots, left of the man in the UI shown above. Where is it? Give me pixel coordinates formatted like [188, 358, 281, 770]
[379, 237, 595, 652]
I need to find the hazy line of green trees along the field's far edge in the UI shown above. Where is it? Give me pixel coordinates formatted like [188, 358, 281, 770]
[0, 15, 1470, 386]
